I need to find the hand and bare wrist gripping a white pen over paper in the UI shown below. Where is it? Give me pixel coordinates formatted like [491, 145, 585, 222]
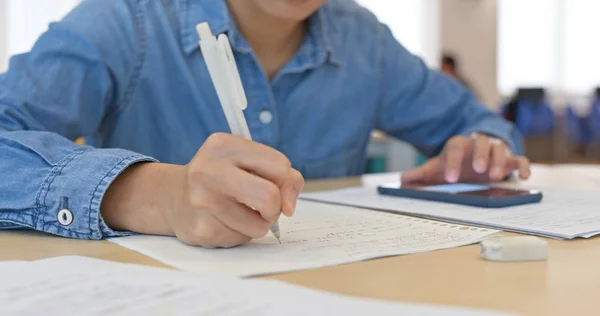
[101, 25, 304, 248]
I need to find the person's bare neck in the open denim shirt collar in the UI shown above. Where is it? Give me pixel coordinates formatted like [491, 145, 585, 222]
[227, 0, 306, 78]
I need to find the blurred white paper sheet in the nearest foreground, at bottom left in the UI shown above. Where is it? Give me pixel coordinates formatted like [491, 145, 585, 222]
[0, 257, 516, 316]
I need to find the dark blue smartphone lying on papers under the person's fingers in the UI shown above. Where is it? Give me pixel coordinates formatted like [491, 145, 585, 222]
[378, 182, 543, 208]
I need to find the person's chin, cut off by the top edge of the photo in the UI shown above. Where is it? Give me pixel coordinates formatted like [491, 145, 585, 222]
[255, 0, 327, 22]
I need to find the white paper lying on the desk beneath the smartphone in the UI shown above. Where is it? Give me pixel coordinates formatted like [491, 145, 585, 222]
[302, 188, 600, 239]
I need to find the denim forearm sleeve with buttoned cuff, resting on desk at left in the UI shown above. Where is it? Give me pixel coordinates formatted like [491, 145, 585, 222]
[0, 132, 155, 239]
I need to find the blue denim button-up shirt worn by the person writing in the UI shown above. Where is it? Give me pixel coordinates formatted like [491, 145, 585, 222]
[0, 0, 521, 239]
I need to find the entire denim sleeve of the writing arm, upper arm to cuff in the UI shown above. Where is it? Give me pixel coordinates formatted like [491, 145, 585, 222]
[0, 0, 150, 239]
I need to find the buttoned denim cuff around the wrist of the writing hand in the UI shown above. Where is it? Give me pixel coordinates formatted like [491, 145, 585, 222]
[34, 149, 157, 239]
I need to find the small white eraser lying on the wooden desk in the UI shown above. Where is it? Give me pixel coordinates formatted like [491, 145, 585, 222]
[480, 236, 548, 262]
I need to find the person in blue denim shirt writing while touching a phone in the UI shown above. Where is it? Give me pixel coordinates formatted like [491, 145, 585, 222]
[0, 0, 529, 247]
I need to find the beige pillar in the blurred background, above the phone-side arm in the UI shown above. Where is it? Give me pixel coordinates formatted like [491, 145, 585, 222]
[440, 0, 500, 108]
